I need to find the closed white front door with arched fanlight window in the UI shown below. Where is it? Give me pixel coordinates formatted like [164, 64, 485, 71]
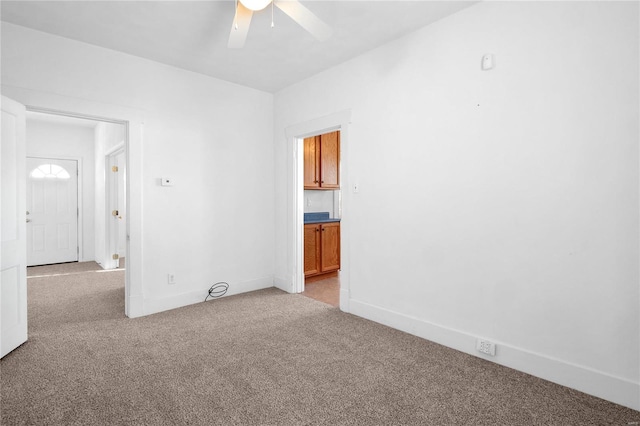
[26, 158, 78, 266]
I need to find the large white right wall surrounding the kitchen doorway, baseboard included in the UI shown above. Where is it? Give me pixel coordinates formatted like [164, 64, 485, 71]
[274, 2, 640, 409]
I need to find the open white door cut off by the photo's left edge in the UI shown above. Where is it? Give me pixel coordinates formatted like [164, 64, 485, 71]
[0, 96, 27, 357]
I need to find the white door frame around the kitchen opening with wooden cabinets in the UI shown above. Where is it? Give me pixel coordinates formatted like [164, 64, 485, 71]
[285, 110, 351, 312]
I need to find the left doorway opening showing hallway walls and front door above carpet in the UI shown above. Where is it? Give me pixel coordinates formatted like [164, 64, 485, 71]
[26, 107, 128, 289]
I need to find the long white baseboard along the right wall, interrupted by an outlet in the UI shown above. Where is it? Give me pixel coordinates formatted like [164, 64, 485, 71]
[350, 293, 640, 411]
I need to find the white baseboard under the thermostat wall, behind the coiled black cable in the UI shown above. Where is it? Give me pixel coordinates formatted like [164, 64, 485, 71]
[143, 277, 273, 315]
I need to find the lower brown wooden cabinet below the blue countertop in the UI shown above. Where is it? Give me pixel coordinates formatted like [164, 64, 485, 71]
[304, 222, 340, 277]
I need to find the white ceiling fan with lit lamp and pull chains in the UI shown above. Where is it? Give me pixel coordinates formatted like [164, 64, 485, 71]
[227, 0, 332, 49]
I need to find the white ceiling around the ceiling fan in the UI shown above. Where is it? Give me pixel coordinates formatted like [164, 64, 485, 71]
[1, 0, 475, 92]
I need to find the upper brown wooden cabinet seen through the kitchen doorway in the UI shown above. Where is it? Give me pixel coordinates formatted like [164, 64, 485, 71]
[304, 131, 340, 189]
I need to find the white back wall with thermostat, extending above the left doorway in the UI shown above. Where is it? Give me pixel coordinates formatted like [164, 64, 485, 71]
[2, 23, 274, 316]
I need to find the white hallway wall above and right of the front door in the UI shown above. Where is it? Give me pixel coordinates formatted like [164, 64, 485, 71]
[27, 118, 95, 262]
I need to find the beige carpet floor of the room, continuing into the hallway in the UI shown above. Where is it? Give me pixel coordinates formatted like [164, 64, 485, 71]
[0, 271, 640, 425]
